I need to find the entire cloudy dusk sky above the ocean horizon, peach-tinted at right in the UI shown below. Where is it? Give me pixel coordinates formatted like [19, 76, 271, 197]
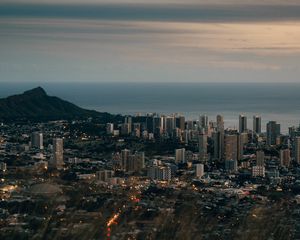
[0, 0, 300, 83]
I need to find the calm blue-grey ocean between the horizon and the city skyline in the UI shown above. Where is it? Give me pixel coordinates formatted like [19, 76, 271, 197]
[0, 83, 300, 133]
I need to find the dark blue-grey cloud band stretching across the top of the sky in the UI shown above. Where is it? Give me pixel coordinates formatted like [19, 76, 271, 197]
[0, 2, 300, 22]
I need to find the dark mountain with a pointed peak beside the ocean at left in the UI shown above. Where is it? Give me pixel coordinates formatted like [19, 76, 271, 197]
[0, 87, 114, 121]
